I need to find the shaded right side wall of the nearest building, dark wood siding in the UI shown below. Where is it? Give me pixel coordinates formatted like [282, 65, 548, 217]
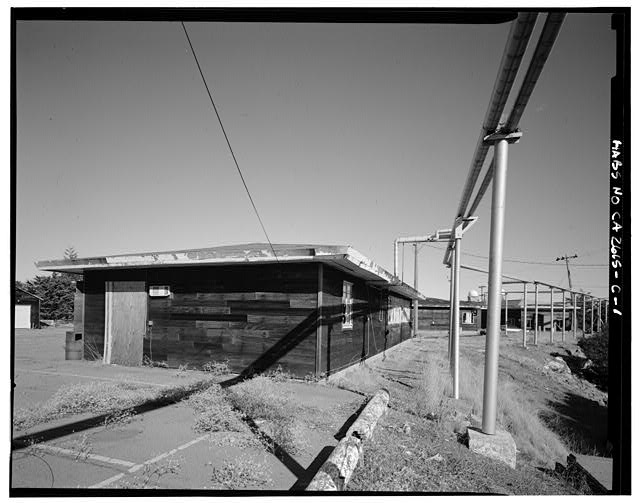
[320, 267, 411, 374]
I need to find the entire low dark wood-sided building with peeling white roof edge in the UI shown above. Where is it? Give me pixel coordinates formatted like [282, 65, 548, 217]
[36, 243, 424, 377]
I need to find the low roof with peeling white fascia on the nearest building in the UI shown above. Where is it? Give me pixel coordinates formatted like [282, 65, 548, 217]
[36, 243, 425, 300]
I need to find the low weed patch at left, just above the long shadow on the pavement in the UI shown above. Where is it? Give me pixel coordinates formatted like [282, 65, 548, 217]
[13, 379, 212, 430]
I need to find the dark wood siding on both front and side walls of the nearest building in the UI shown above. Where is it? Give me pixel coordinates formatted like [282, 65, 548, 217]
[83, 264, 411, 377]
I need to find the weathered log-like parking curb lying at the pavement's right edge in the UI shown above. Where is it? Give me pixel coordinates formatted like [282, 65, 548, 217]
[306, 389, 389, 491]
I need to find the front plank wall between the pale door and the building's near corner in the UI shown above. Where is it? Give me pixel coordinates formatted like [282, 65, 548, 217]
[144, 264, 318, 376]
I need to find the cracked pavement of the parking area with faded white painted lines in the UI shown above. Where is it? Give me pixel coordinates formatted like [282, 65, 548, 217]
[11, 329, 364, 496]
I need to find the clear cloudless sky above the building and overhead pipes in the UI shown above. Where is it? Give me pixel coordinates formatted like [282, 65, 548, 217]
[16, 13, 615, 298]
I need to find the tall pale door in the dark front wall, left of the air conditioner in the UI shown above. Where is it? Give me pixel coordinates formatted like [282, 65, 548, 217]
[104, 281, 147, 366]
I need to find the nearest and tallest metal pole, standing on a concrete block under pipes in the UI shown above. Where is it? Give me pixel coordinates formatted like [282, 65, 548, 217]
[482, 140, 509, 435]
